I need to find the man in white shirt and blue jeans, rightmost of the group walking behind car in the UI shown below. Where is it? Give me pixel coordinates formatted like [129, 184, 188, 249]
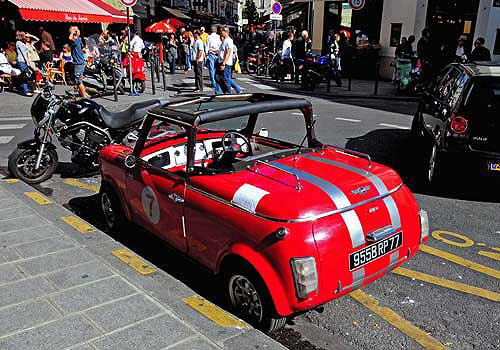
[217, 27, 241, 94]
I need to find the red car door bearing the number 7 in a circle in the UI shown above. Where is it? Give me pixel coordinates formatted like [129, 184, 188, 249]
[126, 120, 187, 252]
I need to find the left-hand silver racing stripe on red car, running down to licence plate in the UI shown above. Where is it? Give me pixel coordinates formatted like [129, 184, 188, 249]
[273, 163, 365, 248]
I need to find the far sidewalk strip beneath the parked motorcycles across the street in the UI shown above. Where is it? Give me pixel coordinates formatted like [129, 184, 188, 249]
[252, 75, 420, 101]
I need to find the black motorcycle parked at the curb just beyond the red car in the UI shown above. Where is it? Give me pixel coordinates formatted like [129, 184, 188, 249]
[8, 85, 167, 184]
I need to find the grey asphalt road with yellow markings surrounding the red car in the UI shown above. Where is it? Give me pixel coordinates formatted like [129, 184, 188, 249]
[0, 77, 500, 350]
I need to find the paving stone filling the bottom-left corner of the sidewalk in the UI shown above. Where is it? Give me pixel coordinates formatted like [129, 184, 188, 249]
[0, 315, 99, 350]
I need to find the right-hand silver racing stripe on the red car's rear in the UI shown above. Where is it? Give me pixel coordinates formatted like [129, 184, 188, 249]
[302, 154, 401, 229]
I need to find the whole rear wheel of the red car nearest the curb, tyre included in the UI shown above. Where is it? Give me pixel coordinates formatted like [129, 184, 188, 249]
[224, 264, 286, 333]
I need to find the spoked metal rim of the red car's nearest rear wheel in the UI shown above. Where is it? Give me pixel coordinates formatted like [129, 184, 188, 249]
[229, 275, 263, 322]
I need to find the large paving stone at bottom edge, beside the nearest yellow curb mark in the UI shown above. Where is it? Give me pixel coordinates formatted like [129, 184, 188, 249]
[94, 315, 194, 350]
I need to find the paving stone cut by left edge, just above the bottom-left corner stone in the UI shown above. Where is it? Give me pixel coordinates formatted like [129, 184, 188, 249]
[0, 300, 58, 337]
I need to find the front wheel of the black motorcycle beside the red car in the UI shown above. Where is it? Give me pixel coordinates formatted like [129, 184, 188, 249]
[8, 148, 58, 184]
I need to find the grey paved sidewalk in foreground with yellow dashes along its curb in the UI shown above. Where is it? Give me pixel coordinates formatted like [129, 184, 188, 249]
[0, 179, 285, 350]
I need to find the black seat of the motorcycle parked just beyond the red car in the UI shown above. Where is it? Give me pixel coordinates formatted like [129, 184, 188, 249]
[100, 100, 169, 129]
